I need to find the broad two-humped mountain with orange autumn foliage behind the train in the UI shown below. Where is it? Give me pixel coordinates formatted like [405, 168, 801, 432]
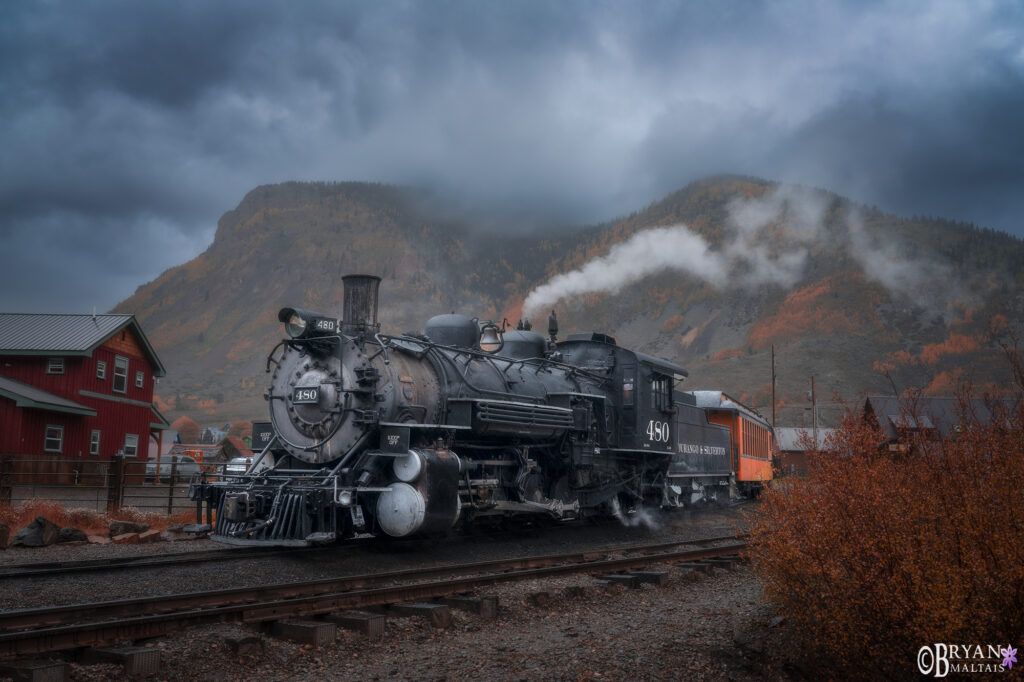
[115, 176, 1024, 424]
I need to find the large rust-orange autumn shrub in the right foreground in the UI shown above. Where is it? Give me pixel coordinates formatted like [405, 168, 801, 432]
[751, 391, 1024, 679]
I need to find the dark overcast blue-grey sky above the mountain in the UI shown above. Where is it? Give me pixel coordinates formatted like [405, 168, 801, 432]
[0, 0, 1024, 312]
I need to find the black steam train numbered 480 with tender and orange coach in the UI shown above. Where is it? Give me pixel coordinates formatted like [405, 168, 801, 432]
[191, 274, 771, 546]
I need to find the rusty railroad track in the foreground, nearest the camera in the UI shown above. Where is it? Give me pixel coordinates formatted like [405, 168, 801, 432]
[0, 538, 745, 659]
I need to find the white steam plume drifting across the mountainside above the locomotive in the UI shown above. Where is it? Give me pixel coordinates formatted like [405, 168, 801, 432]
[523, 185, 952, 317]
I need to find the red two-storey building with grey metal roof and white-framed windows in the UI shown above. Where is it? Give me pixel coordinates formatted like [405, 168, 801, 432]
[0, 313, 168, 461]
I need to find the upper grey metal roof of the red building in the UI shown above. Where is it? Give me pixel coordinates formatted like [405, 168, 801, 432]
[0, 312, 166, 377]
